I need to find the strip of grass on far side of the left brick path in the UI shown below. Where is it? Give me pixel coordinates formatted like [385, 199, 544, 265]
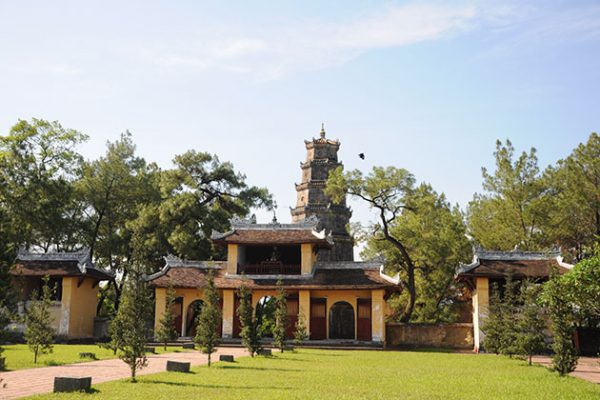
[2, 344, 189, 371]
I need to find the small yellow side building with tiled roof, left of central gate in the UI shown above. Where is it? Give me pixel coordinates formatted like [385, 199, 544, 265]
[10, 249, 114, 339]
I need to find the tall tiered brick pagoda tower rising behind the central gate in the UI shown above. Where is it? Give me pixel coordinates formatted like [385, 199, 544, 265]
[291, 126, 354, 261]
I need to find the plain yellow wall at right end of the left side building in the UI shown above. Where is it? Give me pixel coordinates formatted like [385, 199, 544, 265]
[59, 277, 98, 338]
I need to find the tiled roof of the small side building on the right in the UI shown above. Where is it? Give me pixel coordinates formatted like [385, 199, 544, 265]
[458, 250, 572, 278]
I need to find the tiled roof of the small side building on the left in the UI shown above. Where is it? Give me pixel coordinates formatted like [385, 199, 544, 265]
[10, 250, 114, 280]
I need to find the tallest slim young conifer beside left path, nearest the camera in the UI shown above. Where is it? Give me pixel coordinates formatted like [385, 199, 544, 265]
[112, 266, 152, 382]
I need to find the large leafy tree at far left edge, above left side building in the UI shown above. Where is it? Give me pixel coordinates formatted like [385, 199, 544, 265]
[0, 118, 87, 252]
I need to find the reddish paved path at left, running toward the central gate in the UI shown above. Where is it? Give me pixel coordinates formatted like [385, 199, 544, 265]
[0, 348, 248, 400]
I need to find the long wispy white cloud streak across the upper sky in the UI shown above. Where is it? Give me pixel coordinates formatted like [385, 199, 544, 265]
[154, 3, 486, 80]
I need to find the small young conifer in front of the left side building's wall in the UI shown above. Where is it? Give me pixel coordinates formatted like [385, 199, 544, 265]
[25, 276, 54, 364]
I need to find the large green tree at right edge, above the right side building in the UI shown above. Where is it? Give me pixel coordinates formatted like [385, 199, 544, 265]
[544, 133, 600, 261]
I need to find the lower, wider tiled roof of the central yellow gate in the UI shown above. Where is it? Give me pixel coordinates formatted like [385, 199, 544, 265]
[148, 262, 399, 289]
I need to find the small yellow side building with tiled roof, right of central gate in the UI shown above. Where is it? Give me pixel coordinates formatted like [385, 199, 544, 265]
[457, 249, 573, 352]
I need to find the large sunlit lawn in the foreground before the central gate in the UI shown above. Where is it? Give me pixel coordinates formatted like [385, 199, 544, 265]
[24, 349, 600, 400]
